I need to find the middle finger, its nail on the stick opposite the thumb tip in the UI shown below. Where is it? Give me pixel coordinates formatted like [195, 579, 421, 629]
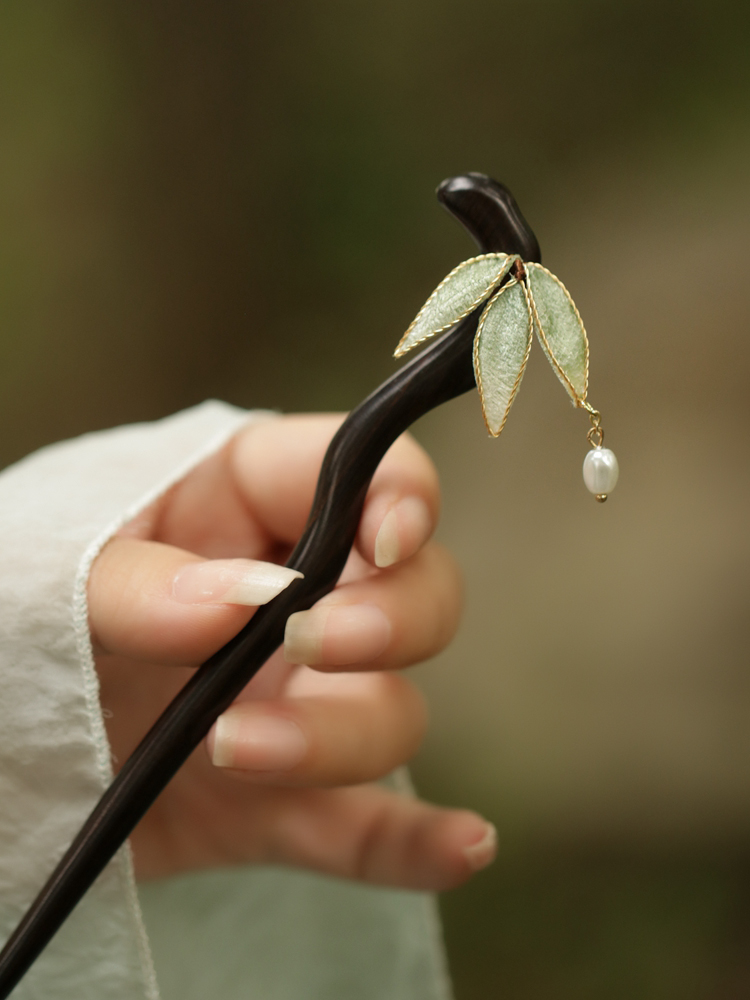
[284, 543, 462, 670]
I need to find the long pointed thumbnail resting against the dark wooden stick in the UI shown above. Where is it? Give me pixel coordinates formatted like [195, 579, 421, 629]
[172, 559, 302, 607]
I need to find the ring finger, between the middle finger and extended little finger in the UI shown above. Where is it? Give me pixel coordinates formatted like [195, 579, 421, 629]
[207, 671, 427, 786]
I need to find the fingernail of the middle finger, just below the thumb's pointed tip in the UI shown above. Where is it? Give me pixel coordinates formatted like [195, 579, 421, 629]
[284, 604, 391, 666]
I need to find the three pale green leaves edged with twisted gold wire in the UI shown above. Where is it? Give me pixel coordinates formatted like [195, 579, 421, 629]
[395, 253, 598, 437]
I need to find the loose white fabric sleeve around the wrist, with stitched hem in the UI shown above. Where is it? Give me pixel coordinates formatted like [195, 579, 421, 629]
[0, 401, 449, 1000]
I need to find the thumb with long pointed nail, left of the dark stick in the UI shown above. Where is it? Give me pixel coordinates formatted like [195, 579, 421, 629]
[88, 538, 300, 665]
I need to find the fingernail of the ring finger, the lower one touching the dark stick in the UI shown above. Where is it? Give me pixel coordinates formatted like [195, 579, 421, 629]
[211, 710, 307, 771]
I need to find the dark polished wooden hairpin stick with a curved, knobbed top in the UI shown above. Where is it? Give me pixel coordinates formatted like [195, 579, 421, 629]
[0, 174, 540, 1000]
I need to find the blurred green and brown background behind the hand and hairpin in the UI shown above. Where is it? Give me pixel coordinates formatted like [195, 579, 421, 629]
[0, 0, 750, 1000]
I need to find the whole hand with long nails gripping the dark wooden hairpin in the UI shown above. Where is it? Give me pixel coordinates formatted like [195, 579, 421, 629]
[89, 416, 495, 889]
